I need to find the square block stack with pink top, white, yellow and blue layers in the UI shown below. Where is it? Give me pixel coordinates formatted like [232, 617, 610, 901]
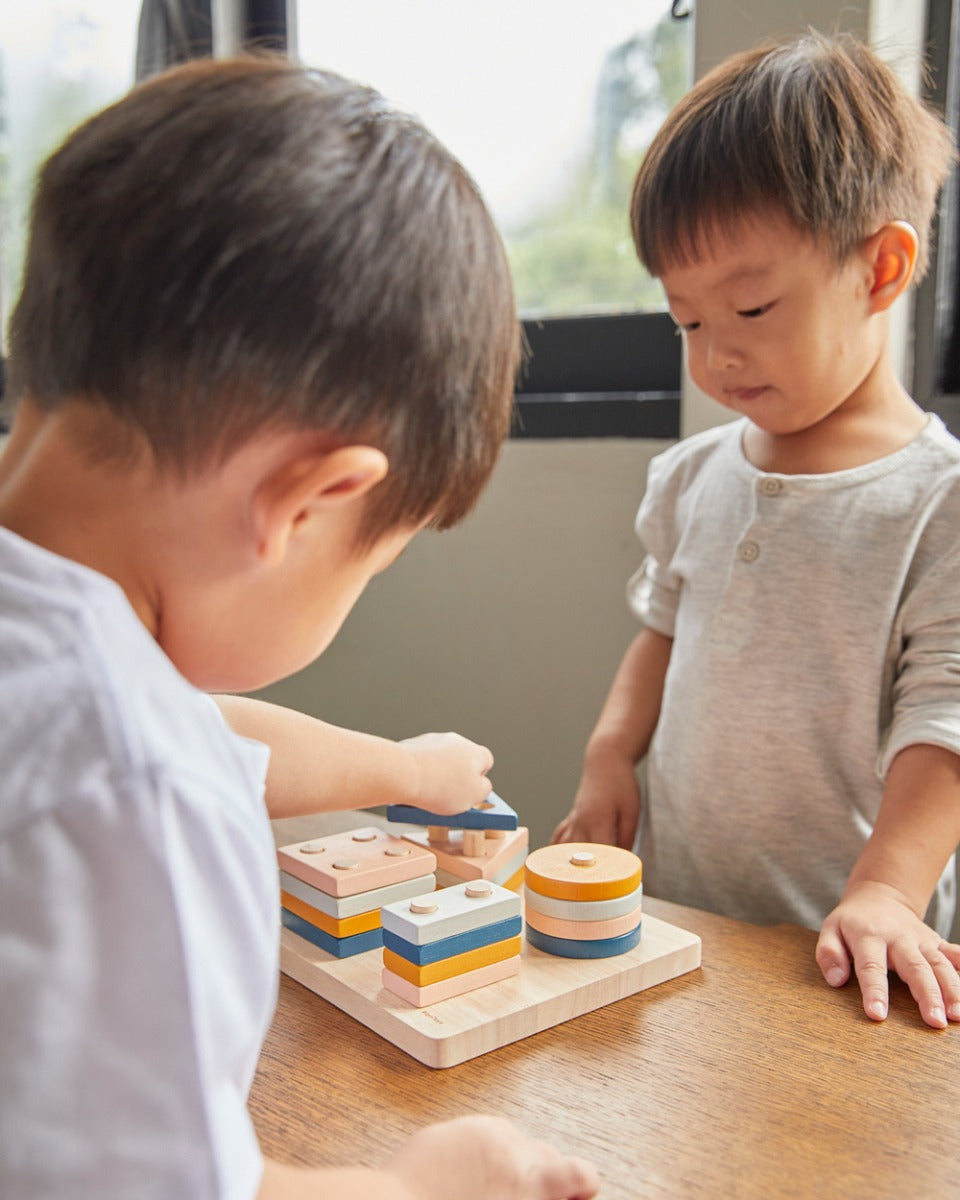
[277, 828, 437, 959]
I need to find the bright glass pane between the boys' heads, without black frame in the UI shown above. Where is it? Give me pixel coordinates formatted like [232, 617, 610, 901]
[298, 0, 691, 317]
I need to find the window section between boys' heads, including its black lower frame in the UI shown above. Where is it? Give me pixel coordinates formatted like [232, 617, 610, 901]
[296, 0, 692, 437]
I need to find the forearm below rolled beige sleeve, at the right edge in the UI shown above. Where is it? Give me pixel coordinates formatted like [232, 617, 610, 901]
[847, 744, 960, 917]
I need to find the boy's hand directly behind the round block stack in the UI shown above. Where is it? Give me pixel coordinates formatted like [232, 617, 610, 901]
[551, 750, 640, 850]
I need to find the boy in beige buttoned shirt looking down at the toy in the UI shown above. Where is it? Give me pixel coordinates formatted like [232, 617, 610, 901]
[554, 34, 960, 1027]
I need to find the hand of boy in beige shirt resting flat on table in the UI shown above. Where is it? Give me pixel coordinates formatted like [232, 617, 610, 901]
[816, 882, 960, 1030]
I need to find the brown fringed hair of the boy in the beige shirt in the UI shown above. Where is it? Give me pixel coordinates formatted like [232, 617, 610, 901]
[630, 32, 955, 278]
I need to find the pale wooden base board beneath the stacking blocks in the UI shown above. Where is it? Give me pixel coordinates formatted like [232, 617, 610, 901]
[280, 916, 701, 1068]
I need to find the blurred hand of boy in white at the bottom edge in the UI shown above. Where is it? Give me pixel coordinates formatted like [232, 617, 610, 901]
[386, 1116, 600, 1200]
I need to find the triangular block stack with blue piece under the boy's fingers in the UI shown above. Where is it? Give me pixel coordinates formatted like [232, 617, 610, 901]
[386, 792, 529, 892]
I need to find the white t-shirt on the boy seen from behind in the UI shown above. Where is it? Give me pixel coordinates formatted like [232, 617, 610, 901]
[0, 529, 278, 1200]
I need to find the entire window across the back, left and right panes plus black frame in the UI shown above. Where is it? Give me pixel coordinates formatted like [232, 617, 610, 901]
[0, 0, 692, 437]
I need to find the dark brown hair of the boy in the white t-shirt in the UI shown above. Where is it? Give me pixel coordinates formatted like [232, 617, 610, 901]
[8, 58, 520, 541]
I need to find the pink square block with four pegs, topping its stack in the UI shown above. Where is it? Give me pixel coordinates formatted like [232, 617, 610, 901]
[277, 827, 437, 896]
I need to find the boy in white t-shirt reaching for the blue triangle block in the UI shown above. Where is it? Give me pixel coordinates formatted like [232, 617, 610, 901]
[0, 59, 598, 1200]
